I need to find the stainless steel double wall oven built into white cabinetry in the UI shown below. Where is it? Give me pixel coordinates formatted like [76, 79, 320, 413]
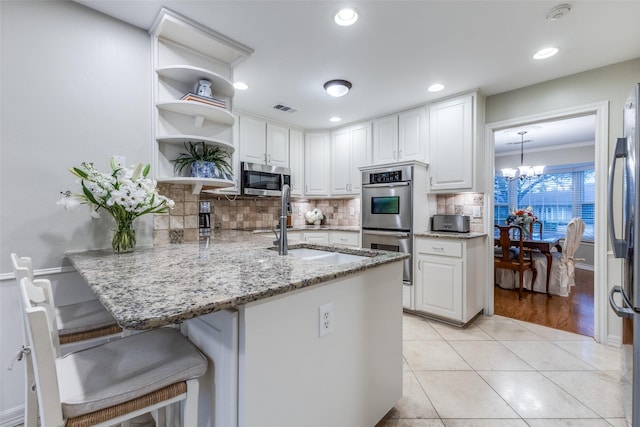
[361, 165, 413, 284]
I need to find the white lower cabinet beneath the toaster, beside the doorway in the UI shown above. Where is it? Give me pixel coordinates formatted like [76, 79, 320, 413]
[414, 237, 486, 324]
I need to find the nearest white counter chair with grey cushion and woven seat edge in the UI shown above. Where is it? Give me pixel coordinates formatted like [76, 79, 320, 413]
[20, 277, 207, 427]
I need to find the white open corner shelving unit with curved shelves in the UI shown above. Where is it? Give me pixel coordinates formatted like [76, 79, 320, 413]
[150, 9, 253, 194]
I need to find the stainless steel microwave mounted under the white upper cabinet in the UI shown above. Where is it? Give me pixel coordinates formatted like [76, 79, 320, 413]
[240, 162, 291, 196]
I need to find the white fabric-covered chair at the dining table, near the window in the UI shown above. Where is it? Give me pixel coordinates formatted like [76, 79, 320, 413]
[524, 218, 584, 297]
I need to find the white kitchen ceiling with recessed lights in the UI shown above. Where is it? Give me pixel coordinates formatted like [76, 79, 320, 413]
[76, 0, 640, 144]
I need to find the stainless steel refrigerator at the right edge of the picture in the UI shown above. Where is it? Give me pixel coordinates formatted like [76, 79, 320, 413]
[608, 83, 640, 427]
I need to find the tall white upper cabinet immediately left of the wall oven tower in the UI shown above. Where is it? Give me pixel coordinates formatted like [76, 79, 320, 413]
[331, 123, 371, 195]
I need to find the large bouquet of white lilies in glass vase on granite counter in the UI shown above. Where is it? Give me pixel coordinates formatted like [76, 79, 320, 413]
[58, 157, 175, 252]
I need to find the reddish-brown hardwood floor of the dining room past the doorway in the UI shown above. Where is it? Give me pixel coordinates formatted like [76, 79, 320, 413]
[494, 268, 593, 337]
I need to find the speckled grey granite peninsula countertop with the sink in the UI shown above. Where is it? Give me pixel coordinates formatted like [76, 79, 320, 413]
[66, 231, 409, 329]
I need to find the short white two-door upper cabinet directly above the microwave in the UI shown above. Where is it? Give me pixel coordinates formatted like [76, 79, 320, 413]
[239, 116, 289, 167]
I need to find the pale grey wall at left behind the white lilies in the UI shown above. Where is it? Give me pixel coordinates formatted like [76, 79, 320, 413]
[0, 1, 152, 426]
